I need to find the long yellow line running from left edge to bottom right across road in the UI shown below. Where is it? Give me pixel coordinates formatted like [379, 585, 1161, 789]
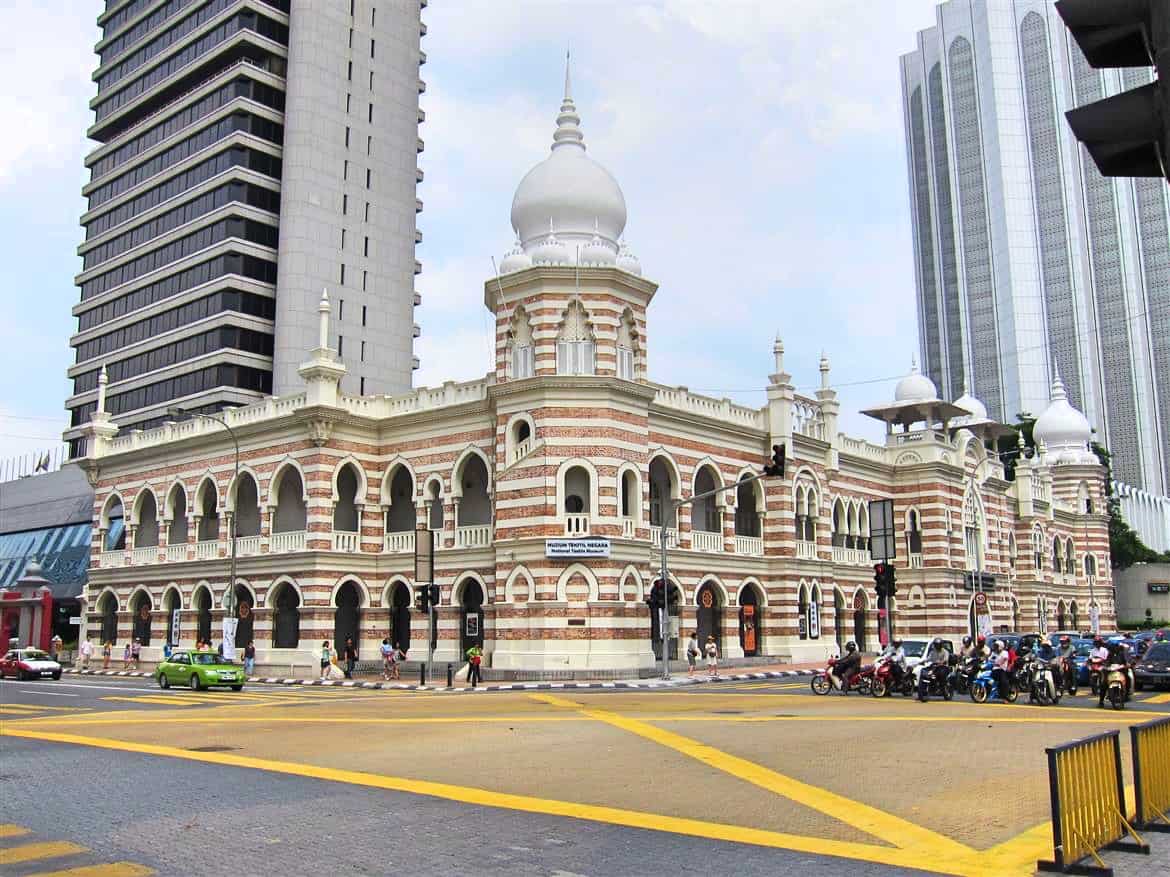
[0, 726, 979, 875]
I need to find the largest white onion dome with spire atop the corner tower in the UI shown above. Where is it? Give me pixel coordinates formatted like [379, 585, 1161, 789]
[511, 60, 626, 258]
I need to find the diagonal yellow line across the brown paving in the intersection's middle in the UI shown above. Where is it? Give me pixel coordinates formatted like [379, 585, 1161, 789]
[534, 695, 973, 857]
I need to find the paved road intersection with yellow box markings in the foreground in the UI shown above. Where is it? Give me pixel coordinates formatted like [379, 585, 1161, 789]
[0, 677, 1170, 877]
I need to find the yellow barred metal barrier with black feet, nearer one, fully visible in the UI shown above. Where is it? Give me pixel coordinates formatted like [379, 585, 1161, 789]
[1037, 731, 1150, 875]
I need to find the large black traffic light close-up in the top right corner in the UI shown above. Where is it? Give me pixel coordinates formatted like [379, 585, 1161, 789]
[1057, 0, 1170, 180]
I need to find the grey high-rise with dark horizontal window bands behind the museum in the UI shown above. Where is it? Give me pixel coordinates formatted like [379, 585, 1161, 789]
[66, 0, 426, 456]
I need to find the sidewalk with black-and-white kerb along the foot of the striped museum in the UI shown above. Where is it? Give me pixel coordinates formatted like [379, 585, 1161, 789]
[64, 664, 823, 691]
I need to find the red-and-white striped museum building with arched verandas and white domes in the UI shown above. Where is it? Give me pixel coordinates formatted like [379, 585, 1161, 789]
[75, 68, 1114, 672]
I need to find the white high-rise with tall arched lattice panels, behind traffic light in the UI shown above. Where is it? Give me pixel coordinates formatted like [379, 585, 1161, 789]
[901, 0, 1170, 493]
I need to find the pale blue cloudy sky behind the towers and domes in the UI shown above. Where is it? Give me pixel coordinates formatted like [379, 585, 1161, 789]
[0, 0, 936, 460]
